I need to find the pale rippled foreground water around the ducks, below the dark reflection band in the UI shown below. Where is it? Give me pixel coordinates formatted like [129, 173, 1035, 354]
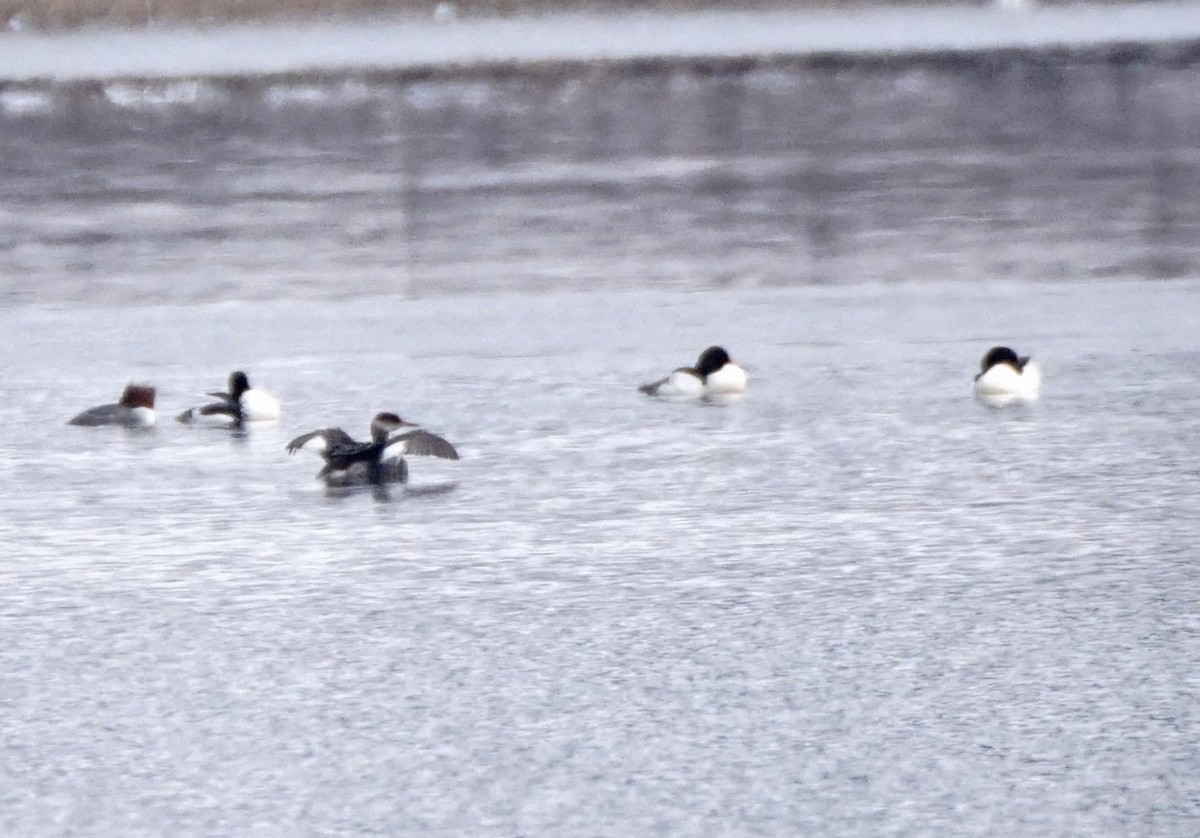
[7, 282, 1200, 834]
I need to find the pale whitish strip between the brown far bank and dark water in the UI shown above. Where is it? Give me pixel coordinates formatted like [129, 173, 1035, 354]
[0, 0, 1200, 86]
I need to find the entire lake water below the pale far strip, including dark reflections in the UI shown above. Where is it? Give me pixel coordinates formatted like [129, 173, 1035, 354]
[0, 8, 1200, 836]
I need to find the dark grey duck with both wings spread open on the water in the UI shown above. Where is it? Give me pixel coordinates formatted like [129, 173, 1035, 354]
[287, 413, 458, 486]
